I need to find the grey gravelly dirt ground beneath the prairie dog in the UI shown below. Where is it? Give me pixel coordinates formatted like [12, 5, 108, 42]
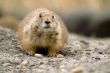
[0, 27, 110, 73]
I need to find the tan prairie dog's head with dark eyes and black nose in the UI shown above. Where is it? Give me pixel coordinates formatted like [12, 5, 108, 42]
[32, 8, 60, 32]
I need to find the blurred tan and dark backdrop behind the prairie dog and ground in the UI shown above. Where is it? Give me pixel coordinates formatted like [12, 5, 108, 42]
[0, 0, 110, 38]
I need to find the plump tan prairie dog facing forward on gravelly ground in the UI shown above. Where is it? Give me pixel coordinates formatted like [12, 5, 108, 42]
[18, 8, 68, 56]
